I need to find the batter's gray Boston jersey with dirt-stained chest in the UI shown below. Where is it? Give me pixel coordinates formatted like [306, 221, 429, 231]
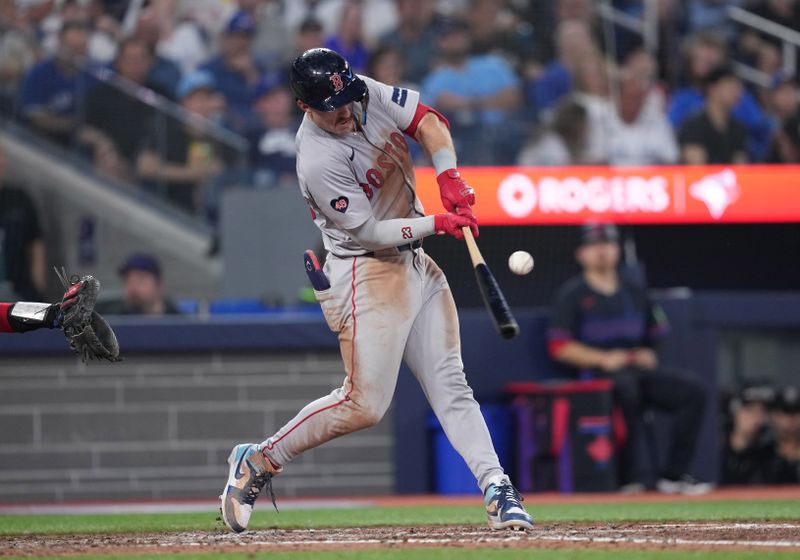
[297, 76, 425, 256]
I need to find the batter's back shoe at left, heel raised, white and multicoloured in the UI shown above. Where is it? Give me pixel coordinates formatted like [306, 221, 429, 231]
[220, 443, 282, 533]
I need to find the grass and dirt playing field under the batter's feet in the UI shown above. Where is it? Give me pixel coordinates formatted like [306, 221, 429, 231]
[0, 496, 800, 560]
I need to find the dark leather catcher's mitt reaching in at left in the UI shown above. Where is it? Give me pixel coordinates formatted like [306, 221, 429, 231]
[56, 269, 122, 363]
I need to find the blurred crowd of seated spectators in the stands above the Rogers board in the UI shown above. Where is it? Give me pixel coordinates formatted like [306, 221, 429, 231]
[0, 0, 800, 221]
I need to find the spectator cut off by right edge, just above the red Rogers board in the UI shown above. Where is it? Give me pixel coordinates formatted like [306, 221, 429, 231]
[767, 76, 800, 163]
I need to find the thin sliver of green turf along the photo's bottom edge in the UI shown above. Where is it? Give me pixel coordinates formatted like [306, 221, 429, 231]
[1, 548, 796, 560]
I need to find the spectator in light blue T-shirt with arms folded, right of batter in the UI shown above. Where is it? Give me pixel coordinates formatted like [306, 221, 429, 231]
[421, 20, 521, 165]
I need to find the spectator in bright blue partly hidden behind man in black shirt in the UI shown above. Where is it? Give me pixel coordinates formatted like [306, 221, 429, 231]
[667, 33, 772, 161]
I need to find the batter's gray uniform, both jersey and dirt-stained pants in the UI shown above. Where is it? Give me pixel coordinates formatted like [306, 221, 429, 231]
[261, 77, 503, 489]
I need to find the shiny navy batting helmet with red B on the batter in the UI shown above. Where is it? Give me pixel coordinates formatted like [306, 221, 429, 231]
[291, 49, 368, 112]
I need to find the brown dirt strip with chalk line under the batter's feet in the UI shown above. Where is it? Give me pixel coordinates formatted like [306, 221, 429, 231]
[0, 522, 800, 556]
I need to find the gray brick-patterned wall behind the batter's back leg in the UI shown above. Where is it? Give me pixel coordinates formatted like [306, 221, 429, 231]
[0, 353, 394, 503]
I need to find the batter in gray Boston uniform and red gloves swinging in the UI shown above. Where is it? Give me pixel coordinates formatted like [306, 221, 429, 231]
[220, 49, 533, 532]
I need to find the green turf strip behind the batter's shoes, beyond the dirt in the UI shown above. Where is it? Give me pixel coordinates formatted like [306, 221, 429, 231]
[0, 500, 800, 535]
